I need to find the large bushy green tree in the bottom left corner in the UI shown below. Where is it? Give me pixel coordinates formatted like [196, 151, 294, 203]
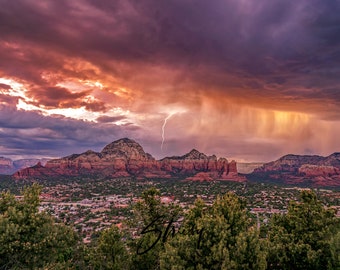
[0, 184, 78, 269]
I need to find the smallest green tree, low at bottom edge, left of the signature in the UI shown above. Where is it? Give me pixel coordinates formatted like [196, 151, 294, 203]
[89, 225, 130, 270]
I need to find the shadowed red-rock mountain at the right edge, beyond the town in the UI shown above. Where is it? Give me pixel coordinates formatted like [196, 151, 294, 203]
[247, 153, 340, 187]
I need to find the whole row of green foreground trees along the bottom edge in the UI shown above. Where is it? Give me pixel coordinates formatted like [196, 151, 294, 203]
[0, 184, 340, 270]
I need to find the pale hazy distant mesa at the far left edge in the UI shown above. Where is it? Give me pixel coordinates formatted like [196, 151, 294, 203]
[0, 157, 48, 175]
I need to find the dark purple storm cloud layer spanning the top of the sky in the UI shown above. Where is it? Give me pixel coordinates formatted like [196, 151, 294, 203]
[0, 0, 340, 107]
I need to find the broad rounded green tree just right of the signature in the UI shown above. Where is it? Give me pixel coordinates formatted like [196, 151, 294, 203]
[161, 193, 266, 270]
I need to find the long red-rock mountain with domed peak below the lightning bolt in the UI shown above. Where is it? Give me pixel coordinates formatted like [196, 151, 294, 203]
[13, 138, 245, 181]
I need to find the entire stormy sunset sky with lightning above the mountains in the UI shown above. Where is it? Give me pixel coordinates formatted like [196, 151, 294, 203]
[0, 0, 340, 162]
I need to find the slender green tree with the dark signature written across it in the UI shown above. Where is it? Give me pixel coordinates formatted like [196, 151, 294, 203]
[130, 187, 182, 269]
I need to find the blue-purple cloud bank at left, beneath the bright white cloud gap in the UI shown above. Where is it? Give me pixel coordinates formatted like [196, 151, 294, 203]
[0, 105, 136, 156]
